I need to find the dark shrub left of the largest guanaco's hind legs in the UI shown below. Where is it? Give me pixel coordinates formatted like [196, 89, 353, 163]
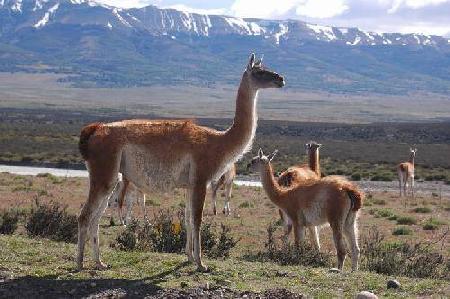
[25, 200, 78, 243]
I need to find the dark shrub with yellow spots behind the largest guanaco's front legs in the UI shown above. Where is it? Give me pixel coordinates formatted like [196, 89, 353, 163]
[112, 210, 238, 258]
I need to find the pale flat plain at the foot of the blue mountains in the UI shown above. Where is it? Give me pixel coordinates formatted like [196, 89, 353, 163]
[0, 73, 450, 123]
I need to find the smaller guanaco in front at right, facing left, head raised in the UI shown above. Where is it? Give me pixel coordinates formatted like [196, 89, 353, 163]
[251, 151, 364, 270]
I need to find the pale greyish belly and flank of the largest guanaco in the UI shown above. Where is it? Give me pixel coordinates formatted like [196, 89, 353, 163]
[120, 145, 193, 192]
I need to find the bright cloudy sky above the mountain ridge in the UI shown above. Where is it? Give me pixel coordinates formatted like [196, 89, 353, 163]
[100, 0, 450, 36]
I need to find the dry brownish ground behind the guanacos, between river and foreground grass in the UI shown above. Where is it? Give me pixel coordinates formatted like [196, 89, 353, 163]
[0, 173, 450, 254]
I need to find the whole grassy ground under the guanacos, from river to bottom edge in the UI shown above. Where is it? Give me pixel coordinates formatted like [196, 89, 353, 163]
[0, 173, 450, 298]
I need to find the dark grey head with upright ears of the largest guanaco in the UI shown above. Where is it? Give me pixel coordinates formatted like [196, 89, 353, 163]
[245, 53, 285, 89]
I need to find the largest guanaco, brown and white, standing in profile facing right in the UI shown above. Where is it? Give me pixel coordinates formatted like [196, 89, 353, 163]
[77, 55, 284, 270]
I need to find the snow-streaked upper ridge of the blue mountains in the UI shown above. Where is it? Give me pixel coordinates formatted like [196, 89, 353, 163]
[0, 0, 450, 46]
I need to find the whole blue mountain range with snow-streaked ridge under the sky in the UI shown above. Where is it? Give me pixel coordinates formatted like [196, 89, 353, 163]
[0, 0, 450, 94]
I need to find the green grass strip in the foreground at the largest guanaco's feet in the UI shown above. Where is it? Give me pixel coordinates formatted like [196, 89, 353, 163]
[0, 236, 449, 298]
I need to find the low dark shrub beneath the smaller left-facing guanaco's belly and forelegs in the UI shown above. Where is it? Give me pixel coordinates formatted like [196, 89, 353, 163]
[244, 223, 332, 267]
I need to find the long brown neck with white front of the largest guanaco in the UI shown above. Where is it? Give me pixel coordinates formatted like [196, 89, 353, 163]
[222, 72, 258, 153]
